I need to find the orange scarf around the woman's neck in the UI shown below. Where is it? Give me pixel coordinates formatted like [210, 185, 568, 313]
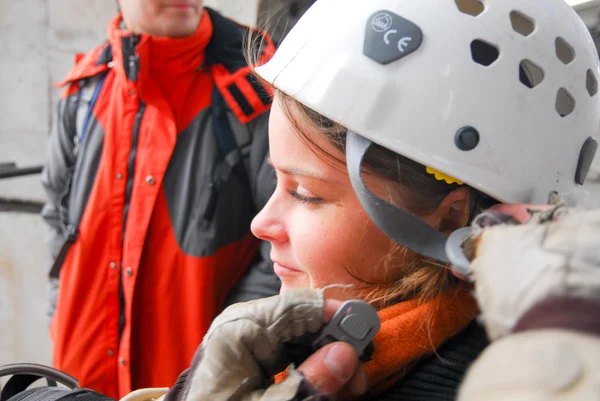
[365, 282, 477, 393]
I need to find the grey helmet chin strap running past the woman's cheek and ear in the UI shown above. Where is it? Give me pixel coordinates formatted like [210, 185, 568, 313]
[346, 131, 450, 263]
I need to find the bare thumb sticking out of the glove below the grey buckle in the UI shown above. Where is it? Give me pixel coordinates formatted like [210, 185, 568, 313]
[298, 342, 366, 395]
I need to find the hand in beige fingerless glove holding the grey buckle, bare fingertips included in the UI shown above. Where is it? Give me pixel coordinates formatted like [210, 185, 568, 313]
[166, 289, 366, 401]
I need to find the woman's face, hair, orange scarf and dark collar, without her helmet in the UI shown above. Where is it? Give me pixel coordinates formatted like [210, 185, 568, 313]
[246, 91, 486, 396]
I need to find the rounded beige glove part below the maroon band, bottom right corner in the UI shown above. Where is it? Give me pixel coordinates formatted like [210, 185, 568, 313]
[457, 329, 600, 401]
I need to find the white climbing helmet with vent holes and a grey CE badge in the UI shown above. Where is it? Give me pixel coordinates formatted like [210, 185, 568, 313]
[257, 0, 600, 203]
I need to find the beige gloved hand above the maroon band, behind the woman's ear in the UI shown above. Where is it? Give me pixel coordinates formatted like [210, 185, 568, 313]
[466, 207, 600, 340]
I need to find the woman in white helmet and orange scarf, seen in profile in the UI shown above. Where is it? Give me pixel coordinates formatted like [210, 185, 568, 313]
[144, 0, 600, 400]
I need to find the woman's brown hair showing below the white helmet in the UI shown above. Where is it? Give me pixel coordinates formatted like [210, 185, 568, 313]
[277, 91, 469, 307]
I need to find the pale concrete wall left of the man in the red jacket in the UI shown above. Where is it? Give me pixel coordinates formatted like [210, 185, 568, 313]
[0, 0, 115, 364]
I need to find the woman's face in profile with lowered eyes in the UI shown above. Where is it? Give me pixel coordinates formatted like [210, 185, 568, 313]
[252, 97, 410, 300]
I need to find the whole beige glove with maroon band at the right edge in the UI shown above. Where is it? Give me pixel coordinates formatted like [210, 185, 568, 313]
[458, 207, 600, 401]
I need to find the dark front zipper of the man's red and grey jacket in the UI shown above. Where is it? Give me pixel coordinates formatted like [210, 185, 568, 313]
[119, 36, 146, 343]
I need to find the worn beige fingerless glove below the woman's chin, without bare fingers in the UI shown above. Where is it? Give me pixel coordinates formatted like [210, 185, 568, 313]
[167, 289, 325, 401]
